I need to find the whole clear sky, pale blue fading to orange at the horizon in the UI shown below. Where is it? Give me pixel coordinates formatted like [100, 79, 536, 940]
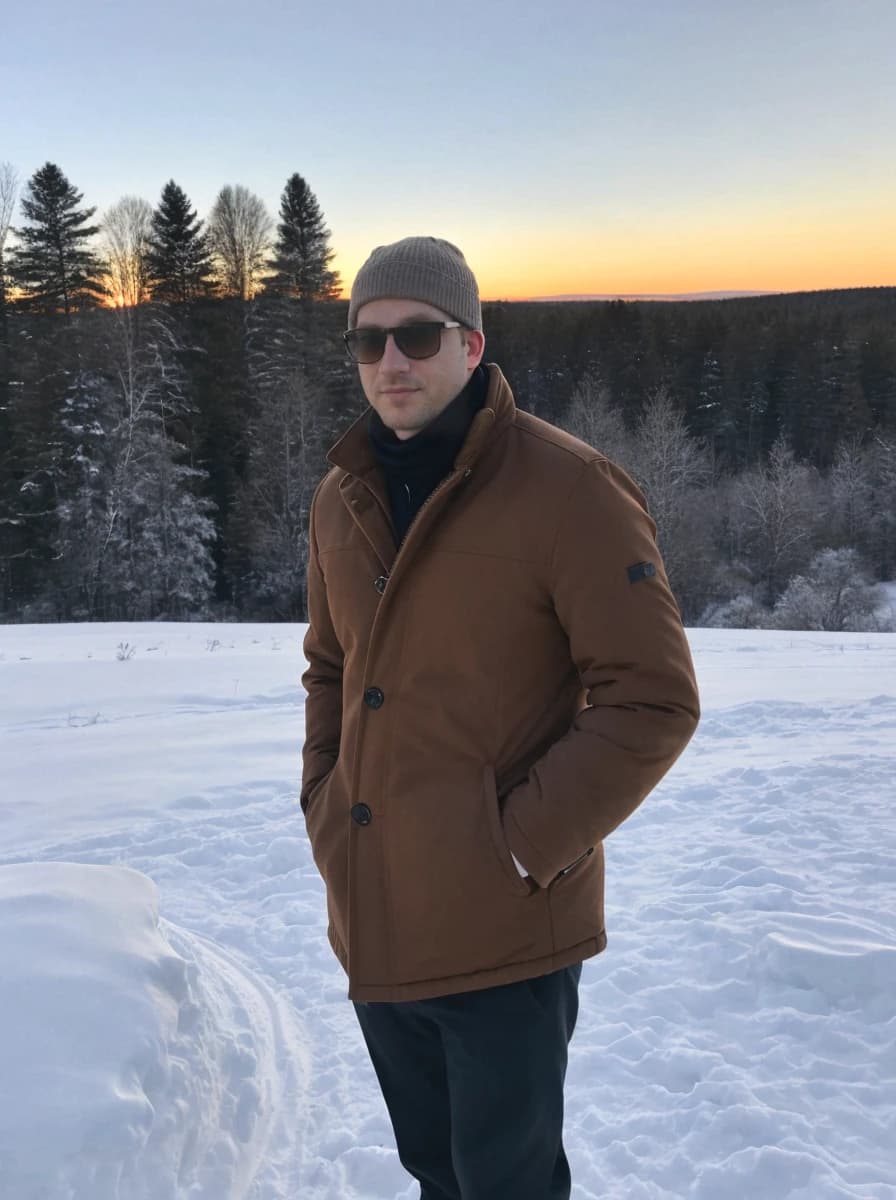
[0, 0, 896, 299]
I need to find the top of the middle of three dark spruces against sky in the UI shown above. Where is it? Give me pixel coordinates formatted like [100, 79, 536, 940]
[146, 179, 212, 304]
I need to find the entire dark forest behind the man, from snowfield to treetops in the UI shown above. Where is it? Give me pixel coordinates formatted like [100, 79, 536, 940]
[0, 163, 896, 629]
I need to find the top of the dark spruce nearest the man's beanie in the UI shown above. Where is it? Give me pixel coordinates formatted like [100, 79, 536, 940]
[267, 173, 339, 300]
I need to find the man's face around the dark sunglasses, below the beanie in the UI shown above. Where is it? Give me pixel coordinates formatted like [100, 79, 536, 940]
[355, 300, 485, 442]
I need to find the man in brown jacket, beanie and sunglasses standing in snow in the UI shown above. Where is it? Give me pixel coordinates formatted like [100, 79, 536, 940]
[301, 238, 698, 1200]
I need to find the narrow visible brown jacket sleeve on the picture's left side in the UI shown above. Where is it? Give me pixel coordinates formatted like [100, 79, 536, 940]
[300, 488, 344, 811]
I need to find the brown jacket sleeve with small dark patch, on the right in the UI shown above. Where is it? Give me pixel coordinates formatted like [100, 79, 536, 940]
[503, 458, 699, 887]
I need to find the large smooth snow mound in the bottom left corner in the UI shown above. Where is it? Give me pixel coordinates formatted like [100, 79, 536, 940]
[0, 863, 307, 1200]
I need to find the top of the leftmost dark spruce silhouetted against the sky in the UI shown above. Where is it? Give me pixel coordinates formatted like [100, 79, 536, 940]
[10, 162, 103, 316]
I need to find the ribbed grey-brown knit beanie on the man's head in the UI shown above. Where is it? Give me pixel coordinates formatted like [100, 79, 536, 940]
[349, 238, 482, 330]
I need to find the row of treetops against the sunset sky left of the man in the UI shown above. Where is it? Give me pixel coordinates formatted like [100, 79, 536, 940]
[0, 162, 339, 316]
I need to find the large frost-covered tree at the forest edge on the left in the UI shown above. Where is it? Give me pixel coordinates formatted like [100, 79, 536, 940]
[55, 311, 215, 620]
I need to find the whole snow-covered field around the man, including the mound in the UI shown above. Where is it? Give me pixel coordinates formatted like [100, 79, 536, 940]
[0, 624, 896, 1200]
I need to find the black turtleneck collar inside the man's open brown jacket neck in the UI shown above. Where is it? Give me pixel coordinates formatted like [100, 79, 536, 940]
[367, 366, 488, 544]
